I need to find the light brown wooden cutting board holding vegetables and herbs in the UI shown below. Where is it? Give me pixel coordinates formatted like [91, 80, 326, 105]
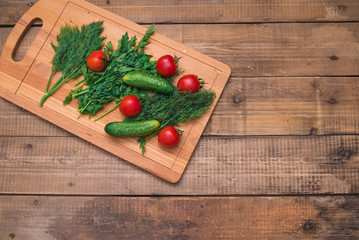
[0, 0, 231, 183]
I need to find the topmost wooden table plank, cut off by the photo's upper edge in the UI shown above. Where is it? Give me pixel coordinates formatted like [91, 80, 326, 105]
[0, 0, 359, 25]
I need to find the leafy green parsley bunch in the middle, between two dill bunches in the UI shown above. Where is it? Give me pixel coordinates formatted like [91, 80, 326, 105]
[64, 25, 157, 120]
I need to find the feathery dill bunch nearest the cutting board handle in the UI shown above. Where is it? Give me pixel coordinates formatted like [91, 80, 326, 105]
[39, 21, 105, 106]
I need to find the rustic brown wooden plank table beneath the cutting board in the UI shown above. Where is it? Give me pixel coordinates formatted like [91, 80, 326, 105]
[0, 0, 359, 239]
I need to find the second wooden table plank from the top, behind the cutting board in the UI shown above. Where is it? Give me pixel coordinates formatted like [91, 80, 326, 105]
[0, 23, 359, 77]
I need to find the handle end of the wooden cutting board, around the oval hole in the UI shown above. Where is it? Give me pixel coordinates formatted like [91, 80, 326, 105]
[0, 0, 63, 82]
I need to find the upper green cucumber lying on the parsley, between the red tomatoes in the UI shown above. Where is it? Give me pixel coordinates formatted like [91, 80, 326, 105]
[123, 71, 174, 95]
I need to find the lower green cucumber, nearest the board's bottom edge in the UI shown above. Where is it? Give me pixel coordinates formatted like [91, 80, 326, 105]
[105, 120, 160, 137]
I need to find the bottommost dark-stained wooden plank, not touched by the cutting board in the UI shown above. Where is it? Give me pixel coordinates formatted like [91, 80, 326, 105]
[0, 196, 359, 240]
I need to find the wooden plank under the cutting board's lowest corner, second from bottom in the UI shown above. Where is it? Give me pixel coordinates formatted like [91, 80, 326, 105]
[0, 135, 359, 195]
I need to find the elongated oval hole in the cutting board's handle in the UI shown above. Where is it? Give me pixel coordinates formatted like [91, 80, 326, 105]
[11, 18, 43, 62]
